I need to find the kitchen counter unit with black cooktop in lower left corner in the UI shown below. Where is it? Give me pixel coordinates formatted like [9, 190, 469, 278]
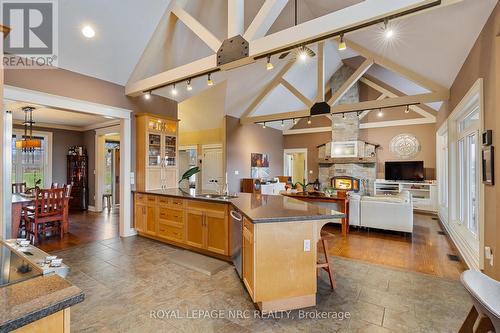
[0, 241, 84, 332]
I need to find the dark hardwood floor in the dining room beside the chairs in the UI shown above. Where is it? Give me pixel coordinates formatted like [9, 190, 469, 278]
[37, 209, 119, 252]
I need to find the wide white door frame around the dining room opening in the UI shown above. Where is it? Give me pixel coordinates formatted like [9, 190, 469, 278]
[0, 85, 136, 238]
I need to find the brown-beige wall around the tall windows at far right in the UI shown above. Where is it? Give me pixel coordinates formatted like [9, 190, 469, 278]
[437, 4, 500, 280]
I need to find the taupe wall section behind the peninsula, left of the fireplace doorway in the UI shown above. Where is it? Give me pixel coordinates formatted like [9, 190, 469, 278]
[225, 116, 283, 192]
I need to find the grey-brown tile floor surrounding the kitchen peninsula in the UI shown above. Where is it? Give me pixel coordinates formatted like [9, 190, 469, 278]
[53, 237, 471, 333]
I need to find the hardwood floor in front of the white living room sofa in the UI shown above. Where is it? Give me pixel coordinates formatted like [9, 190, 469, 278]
[322, 214, 466, 280]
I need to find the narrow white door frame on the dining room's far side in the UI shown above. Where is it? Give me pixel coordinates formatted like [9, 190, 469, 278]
[93, 125, 121, 212]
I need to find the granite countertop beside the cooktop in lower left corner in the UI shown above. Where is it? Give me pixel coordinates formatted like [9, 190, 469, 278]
[0, 274, 85, 332]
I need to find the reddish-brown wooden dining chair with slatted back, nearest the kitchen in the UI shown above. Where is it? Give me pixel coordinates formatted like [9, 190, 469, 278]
[25, 188, 66, 244]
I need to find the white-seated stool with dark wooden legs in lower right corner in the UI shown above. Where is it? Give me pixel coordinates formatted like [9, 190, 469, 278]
[460, 270, 500, 333]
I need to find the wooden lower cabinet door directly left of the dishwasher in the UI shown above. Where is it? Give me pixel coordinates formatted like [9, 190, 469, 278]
[205, 211, 229, 255]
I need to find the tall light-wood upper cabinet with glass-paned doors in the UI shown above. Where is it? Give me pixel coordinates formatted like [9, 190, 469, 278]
[136, 113, 179, 191]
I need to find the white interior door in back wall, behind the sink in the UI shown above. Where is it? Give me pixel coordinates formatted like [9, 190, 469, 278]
[201, 145, 224, 191]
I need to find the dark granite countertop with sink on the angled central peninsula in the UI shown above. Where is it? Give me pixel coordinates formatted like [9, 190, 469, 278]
[132, 189, 345, 223]
